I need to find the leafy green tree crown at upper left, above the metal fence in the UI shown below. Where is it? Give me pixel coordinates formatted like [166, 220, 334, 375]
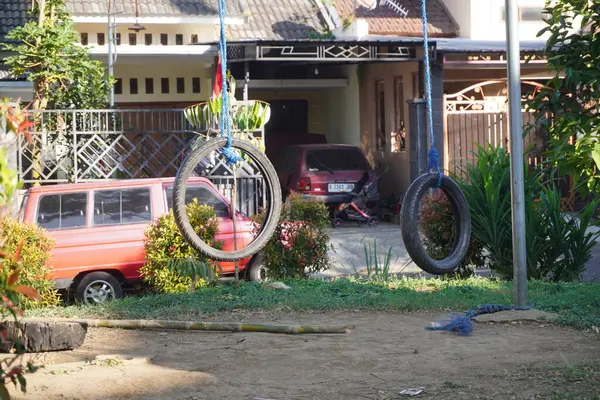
[1, 0, 113, 110]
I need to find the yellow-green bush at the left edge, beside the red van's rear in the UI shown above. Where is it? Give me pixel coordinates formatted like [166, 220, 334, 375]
[0, 215, 61, 308]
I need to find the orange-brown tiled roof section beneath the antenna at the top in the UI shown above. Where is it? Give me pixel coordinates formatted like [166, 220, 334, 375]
[334, 0, 460, 37]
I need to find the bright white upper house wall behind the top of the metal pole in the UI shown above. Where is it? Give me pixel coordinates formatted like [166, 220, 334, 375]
[443, 0, 547, 40]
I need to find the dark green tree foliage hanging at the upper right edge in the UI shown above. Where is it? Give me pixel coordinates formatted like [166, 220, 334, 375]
[528, 0, 600, 197]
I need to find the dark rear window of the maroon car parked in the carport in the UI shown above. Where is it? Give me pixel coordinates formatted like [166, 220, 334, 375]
[306, 147, 370, 172]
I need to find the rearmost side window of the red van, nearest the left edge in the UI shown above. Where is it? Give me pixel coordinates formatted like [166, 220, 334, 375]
[37, 193, 87, 230]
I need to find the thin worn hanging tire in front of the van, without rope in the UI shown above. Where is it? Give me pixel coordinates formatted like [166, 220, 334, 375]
[173, 138, 282, 261]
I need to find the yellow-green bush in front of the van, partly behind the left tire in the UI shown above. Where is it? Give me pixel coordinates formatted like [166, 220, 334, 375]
[140, 199, 222, 293]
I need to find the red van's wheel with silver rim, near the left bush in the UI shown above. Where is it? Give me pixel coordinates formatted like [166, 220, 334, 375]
[75, 272, 123, 305]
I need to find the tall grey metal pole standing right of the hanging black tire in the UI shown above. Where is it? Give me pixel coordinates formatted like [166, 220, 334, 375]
[505, 0, 527, 306]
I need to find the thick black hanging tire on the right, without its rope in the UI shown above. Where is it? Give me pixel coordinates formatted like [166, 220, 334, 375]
[400, 173, 471, 275]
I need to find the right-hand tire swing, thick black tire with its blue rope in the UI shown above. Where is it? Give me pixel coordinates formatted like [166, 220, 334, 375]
[400, 0, 471, 275]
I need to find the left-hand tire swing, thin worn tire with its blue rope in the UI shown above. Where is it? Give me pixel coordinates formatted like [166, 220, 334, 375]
[173, 0, 282, 261]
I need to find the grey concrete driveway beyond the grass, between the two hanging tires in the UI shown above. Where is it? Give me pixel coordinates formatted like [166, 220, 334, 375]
[322, 222, 600, 281]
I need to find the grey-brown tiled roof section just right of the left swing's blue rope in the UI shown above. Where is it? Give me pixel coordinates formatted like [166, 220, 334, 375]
[227, 0, 326, 40]
